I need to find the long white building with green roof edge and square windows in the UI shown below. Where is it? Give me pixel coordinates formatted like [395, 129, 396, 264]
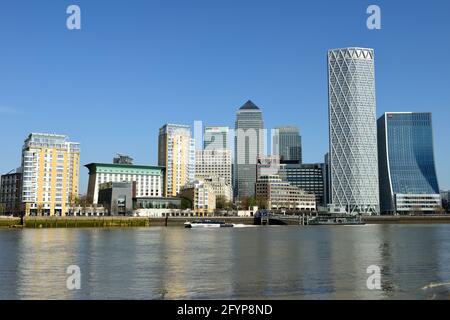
[85, 163, 164, 204]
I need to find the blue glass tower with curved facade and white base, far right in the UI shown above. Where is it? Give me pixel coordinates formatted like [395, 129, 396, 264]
[378, 112, 441, 214]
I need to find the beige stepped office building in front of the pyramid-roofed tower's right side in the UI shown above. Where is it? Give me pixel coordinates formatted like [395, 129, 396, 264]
[256, 175, 316, 211]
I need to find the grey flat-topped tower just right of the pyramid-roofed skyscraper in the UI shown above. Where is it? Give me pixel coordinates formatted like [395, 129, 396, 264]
[272, 126, 302, 163]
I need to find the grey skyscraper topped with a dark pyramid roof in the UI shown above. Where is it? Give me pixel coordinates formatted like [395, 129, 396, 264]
[234, 100, 264, 198]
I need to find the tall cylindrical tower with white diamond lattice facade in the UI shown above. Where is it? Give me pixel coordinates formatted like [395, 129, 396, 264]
[328, 48, 379, 214]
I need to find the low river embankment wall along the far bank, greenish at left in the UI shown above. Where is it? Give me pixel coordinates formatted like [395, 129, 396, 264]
[0, 215, 450, 229]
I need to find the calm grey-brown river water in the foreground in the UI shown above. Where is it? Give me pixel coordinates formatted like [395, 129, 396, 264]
[0, 225, 450, 299]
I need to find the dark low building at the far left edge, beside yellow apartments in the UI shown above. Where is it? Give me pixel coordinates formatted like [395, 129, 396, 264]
[0, 168, 22, 216]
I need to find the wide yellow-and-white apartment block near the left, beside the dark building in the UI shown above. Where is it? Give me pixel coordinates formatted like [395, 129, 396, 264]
[22, 133, 80, 216]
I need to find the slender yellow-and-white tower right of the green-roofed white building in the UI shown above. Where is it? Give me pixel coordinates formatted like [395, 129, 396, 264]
[158, 124, 195, 197]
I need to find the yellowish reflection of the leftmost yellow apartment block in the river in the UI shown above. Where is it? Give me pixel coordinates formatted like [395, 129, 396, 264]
[17, 229, 77, 299]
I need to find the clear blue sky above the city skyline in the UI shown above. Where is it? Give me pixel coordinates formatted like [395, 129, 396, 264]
[0, 0, 450, 192]
